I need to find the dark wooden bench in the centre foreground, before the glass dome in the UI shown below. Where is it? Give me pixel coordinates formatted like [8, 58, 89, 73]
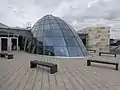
[30, 60, 57, 74]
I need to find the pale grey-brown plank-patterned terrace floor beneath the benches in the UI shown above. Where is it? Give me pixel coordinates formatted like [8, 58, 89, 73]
[0, 52, 120, 90]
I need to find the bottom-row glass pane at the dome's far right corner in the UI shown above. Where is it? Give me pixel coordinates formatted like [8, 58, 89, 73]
[67, 47, 83, 57]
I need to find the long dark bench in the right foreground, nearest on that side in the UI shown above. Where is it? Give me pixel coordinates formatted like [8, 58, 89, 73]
[87, 60, 119, 70]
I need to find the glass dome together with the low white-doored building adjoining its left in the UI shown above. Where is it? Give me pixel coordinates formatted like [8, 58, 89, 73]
[0, 15, 87, 57]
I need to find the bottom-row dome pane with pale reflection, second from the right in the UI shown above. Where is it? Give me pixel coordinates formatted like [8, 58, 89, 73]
[54, 47, 69, 56]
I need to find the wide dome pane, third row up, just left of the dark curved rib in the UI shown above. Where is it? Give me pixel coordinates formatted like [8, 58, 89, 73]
[44, 30, 62, 37]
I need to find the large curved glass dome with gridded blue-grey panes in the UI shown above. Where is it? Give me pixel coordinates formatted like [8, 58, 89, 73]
[31, 15, 87, 57]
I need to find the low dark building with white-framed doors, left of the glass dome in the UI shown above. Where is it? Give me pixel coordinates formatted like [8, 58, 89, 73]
[0, 24, 32, 52]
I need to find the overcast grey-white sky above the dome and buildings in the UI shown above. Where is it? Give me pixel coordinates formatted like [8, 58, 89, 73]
[0, 0, 120, 29]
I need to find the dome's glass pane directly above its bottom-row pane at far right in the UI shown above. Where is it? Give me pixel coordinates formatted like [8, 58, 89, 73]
[64, 37, 79, 46]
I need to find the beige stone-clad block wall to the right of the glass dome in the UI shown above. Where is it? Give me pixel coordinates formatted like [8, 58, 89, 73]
[78, 26, 110, 52]
